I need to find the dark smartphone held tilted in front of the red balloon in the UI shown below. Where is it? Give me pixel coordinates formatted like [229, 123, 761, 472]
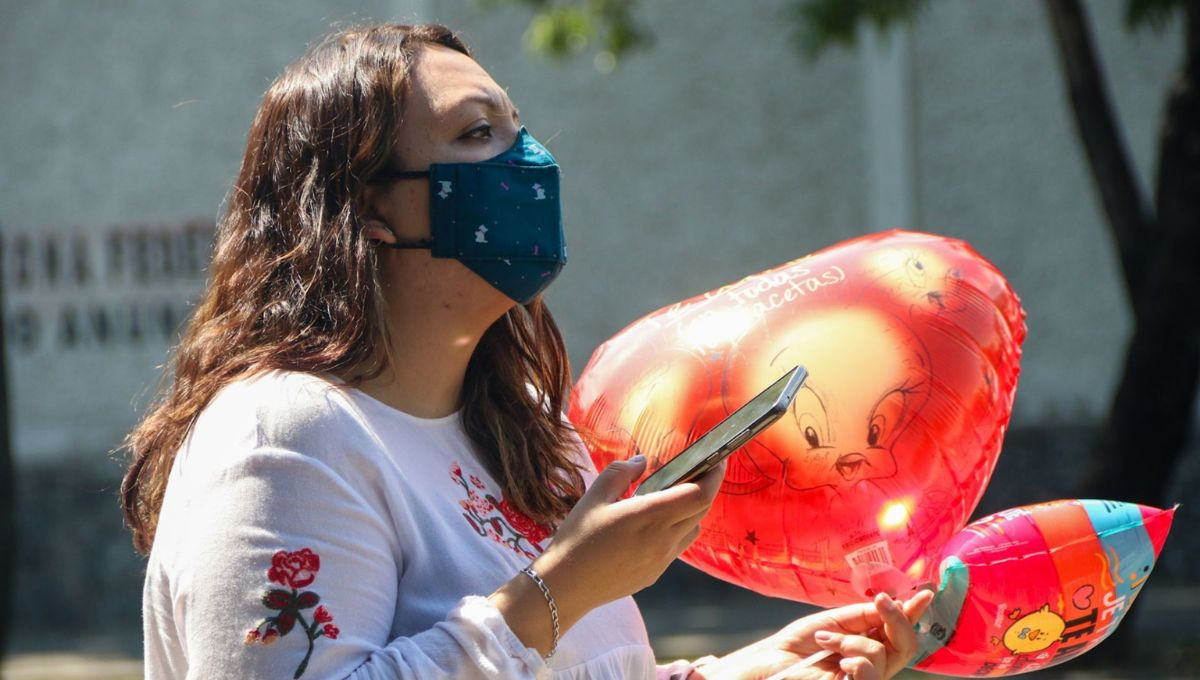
[634, 366, 809, 495]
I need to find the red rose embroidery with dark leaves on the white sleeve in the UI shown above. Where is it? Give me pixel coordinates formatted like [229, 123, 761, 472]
[246, 548, 341, 680]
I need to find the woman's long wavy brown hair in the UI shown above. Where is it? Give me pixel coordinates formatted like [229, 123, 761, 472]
[121, 24, 583, 553]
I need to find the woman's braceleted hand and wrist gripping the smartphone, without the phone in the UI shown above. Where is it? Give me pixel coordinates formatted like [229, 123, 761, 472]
[491, 456, 725, 652]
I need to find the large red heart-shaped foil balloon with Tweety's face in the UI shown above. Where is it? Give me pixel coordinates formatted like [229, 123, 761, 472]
[569, 231, 1025, 606]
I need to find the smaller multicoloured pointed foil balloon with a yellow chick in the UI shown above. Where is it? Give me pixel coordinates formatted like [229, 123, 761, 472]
[913, 500, 1175, 678]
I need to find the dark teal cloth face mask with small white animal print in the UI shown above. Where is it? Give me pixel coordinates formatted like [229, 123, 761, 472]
[380, 127, 566, 305]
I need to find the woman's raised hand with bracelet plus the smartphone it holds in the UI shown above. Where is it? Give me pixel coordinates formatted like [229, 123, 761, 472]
[491, 366, 808, 662]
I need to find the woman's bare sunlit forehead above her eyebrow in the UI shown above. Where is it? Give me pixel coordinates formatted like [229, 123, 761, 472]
[410, 46, 512, 115]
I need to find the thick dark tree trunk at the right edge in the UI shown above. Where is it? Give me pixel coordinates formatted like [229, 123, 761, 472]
[1081, 2, 1200, 510]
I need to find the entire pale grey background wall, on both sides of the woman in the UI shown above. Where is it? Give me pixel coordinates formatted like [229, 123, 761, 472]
[0, 0, 1180, 647]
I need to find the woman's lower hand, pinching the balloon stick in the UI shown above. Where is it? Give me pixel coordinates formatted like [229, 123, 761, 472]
[691, 590, 934, 680]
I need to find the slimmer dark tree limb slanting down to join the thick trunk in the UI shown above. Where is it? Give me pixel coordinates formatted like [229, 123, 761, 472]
[1045, 0, 1159, 314]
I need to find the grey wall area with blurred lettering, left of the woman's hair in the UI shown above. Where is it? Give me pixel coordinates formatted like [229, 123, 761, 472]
[0, 0, 432, 458]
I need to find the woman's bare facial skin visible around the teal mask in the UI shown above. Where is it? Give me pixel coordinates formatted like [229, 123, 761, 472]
[367, 46, 521, 315]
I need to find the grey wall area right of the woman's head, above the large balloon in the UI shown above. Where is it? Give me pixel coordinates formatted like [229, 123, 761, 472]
[436, 0, 1180, 426]
